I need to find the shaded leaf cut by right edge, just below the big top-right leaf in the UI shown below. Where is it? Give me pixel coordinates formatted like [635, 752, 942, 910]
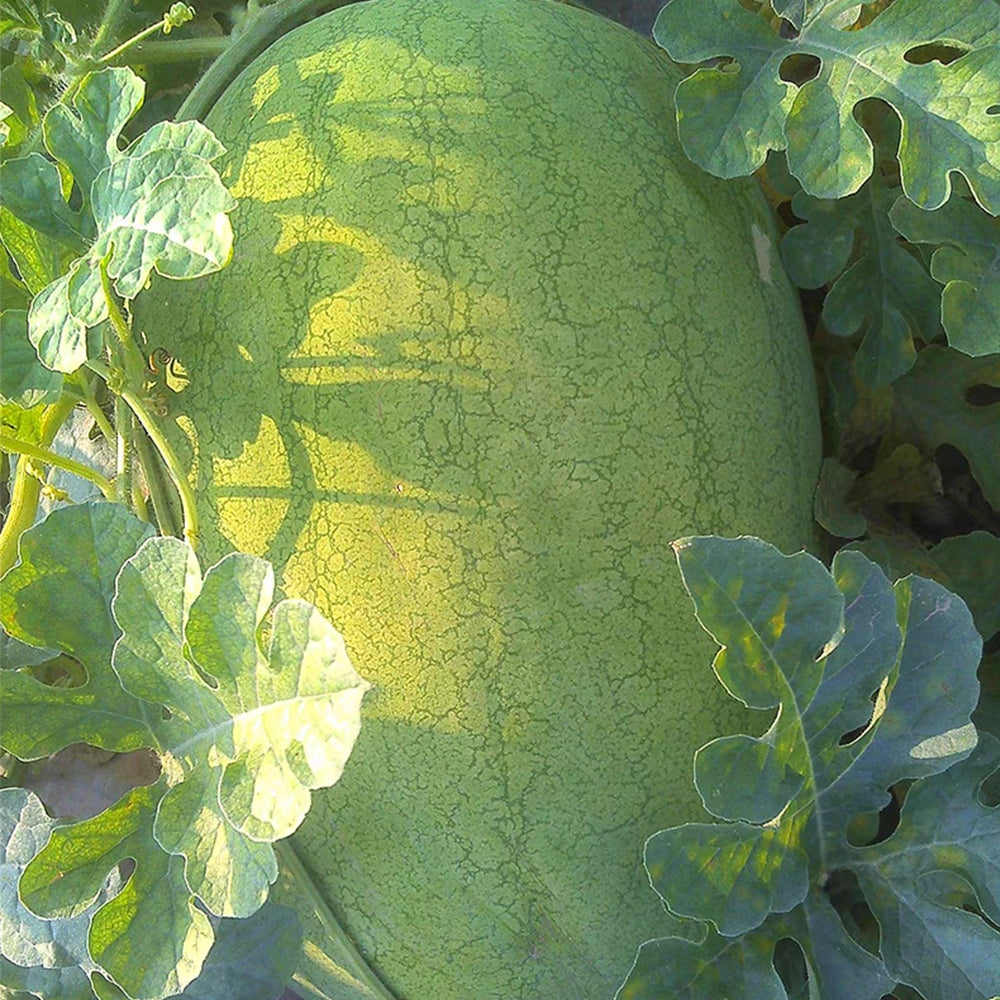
[889, 195, 1000, 357]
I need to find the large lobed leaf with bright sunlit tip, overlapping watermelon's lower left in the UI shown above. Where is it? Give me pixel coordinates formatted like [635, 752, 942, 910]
[0, 504, 368, 997]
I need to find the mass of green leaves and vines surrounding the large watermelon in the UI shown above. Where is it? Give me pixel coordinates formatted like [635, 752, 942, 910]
[0, 0, 1000, 1000]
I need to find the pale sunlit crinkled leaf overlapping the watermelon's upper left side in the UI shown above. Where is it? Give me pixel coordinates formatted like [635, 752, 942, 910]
[2, 68, 236, 374]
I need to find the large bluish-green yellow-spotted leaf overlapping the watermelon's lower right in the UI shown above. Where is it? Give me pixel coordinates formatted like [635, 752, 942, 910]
[619, 538, 1000, 1000]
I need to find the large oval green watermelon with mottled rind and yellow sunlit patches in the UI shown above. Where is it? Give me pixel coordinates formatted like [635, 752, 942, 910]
[139, 0, 819, 1000]
